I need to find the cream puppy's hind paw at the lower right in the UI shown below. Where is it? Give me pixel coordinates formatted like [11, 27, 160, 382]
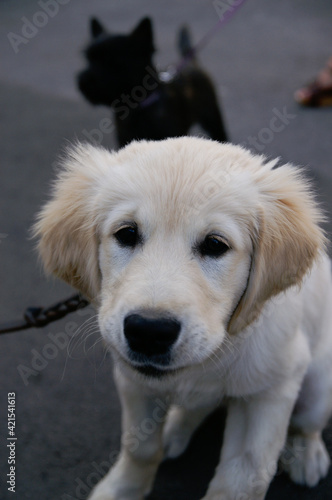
[280, 433, 330, 486]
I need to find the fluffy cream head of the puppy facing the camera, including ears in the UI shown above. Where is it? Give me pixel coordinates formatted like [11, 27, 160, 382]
[35, 137, 324, 375]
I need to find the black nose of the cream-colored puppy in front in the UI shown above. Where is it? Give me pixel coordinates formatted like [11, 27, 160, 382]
[124, 314, 181, 356]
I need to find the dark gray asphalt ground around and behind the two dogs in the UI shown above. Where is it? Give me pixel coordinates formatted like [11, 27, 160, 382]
[0, 0, 332, 500]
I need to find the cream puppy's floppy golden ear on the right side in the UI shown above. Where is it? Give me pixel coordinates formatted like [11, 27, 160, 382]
[228, 162, 326, 334]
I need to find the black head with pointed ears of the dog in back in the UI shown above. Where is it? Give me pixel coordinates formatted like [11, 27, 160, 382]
[77, 18, 154, 106]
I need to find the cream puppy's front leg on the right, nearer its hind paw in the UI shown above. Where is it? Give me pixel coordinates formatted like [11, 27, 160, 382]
[202, 387, 297, 500]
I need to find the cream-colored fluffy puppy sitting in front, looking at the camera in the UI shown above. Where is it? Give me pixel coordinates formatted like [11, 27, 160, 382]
[35, 137, 332, 500]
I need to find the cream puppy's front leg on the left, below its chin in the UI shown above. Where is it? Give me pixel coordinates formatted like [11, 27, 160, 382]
[89, 376, 167, 500]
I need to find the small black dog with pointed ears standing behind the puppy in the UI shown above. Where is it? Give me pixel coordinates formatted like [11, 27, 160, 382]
[78, 18, 227, 146]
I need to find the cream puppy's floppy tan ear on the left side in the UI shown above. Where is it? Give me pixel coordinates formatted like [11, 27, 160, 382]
[33, 144, 110, 301]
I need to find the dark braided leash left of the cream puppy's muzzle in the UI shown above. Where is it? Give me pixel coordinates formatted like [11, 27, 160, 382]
[0, 294, 89, 334]
